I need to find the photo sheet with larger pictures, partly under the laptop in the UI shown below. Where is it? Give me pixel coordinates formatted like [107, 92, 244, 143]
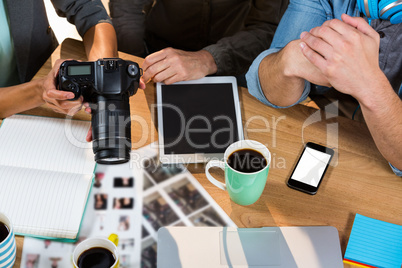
[136, 144, 236, 268]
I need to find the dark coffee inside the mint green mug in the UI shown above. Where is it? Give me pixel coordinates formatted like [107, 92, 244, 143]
[227, 149, 267, 173]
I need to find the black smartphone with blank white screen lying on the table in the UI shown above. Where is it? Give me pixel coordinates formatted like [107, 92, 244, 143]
[287, 142, 334, 194]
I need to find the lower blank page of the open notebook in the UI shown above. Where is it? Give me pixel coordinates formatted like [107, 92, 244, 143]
[0, 166, 92, 239]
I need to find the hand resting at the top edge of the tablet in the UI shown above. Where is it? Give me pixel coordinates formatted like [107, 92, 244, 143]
[141, 48, 217, 84]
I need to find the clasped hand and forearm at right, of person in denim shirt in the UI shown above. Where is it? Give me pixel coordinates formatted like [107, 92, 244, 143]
[302, 14, 402, 169]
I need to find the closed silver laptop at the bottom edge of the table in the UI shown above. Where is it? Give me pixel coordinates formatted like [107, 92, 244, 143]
[157, 226, 343, 268]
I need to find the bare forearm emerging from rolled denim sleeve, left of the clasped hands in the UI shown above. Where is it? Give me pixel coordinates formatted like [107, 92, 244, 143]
[258, 40, 305, 107]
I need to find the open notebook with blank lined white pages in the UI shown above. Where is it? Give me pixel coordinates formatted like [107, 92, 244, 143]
[0, 115, 95, 240]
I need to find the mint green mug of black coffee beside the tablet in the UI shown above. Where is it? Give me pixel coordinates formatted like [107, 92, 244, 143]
[205, 140, 271, 206]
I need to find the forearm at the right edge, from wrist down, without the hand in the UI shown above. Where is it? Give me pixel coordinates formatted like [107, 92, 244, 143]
[358, 76, 402, 170]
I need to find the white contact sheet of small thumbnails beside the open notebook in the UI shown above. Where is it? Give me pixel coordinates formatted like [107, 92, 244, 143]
[21, 163, 143, 268]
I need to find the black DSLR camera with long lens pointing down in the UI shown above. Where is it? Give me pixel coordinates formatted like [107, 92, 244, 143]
[57, 58, 142, 164]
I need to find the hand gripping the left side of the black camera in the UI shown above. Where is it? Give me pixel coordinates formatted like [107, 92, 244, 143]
[42, 59, 83, 115]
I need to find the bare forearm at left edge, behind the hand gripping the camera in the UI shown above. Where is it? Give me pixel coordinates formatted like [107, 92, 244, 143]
[0, 79, 44, 118]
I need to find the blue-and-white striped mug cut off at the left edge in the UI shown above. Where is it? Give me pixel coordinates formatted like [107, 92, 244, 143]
[0, 212, 17, 268]
